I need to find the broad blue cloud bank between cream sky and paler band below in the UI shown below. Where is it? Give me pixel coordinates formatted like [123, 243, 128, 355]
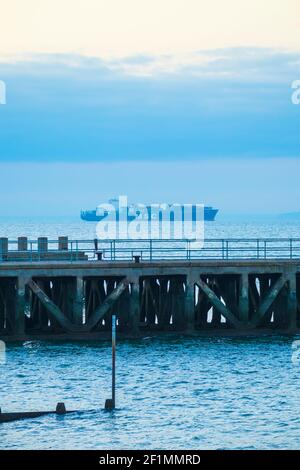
[0, 48, 300, 161]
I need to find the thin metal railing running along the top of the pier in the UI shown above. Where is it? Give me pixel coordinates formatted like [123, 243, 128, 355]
[0, 237, 300, 262]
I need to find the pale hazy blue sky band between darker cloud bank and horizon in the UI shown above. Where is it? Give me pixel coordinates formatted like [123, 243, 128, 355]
[0, 158, 300, 218]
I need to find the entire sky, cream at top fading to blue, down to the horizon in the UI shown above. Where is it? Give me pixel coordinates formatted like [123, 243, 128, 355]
[0, 0, 300, 215]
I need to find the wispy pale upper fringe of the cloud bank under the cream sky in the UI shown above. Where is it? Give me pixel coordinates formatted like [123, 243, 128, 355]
[0, 47, 300, 82]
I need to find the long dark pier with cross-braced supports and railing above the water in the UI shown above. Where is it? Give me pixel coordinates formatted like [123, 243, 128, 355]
[0, 237, 300, 341]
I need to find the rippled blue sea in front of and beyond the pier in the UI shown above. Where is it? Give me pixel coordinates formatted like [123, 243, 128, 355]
[0, 218, 300, 450]
